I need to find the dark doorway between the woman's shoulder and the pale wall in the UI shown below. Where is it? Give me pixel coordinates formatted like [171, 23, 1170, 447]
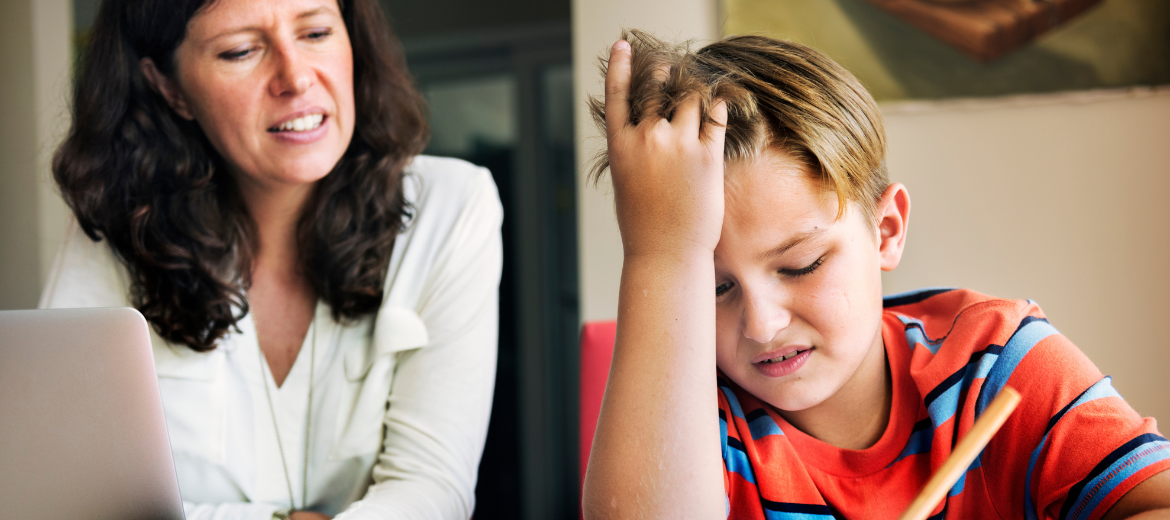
[383, 0, 580, 520]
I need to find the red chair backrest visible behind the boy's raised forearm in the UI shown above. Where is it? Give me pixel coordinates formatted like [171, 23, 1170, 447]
[579, 321, 618, 494]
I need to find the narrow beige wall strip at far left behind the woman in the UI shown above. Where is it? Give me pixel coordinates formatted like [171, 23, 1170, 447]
[0, 0, 73, 309]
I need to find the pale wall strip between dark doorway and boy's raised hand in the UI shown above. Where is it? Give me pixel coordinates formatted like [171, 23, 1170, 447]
[572, 0, 718, 321]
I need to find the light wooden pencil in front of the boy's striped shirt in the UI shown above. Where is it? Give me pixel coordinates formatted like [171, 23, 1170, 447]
[900, 386, 1020, 520]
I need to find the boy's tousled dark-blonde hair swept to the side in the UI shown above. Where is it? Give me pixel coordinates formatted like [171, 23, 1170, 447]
[589, 30, 889, 219]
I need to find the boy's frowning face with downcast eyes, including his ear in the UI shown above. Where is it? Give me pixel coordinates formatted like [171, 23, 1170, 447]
[715, 152, 909, 412]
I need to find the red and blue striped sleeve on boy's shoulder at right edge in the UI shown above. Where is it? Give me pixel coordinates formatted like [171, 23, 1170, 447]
[985, 305, 1170, 520]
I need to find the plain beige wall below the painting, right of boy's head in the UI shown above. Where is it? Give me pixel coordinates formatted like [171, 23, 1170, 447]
[883, 87, 1170, 421]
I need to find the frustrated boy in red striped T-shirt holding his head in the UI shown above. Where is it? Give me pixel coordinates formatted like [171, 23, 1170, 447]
[583, 33, 1170, 519]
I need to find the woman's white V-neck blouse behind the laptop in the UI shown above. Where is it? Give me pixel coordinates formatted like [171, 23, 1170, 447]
[41, 156, 503, 520]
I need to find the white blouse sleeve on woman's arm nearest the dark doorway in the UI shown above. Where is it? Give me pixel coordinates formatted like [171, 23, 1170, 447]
[337, 169, 503, 520]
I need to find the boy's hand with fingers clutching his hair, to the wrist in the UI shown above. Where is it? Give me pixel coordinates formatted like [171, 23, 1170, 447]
[605, 41, 727, 258]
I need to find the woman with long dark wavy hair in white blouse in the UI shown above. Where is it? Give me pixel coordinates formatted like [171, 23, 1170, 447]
[42, 0, 502, 520]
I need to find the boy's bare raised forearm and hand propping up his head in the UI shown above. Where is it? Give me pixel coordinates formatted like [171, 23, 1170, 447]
[583, 41, 727, 519]
